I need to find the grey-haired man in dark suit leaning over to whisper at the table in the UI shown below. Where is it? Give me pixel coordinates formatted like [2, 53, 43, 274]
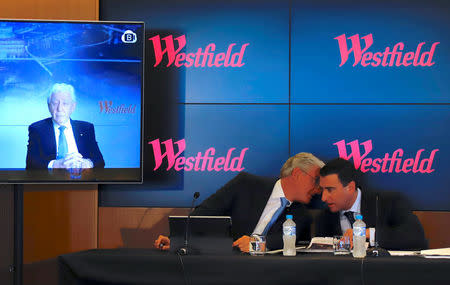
[154, 153, 324, 252]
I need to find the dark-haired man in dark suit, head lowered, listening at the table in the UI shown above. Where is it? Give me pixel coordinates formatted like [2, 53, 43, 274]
[316, 158, 427, 250]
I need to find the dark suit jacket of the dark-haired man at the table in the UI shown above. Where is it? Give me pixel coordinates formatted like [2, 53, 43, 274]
[316, 190, 428, 250]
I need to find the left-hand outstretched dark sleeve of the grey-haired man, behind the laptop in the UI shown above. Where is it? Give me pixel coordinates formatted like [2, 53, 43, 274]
[192, 172, 245, 216]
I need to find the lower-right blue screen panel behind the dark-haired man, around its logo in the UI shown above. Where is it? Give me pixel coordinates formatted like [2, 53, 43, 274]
[291, 105, 450, 210]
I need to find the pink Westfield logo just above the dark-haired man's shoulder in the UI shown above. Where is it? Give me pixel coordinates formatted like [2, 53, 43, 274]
[333, 140, 439, 173]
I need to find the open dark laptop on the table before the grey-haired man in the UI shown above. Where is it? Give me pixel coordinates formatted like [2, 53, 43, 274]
[169, 216, 233, 255]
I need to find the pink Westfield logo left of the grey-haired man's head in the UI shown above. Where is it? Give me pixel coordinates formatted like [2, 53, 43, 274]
[149, 139, 248, 171]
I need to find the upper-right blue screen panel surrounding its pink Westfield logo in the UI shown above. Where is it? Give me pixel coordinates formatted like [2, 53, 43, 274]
[291, 0, 450, 103]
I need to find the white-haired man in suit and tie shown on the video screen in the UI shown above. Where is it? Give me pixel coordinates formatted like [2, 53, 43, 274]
[26, 83, 105, 169]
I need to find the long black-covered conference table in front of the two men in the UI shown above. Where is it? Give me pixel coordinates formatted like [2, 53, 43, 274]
[58, 248, 450, 285]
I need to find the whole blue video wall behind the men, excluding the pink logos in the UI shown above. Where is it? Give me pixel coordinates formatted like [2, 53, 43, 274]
[100, 0, 450, 210]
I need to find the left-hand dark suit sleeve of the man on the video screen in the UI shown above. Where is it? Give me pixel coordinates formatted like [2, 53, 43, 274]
[26, 125, 52, 169]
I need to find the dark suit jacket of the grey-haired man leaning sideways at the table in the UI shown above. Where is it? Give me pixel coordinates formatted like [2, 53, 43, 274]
[193, 172, 311, 249]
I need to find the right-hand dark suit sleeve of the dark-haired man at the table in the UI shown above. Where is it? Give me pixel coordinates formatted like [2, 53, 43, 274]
[375, 193, 428, 250]
